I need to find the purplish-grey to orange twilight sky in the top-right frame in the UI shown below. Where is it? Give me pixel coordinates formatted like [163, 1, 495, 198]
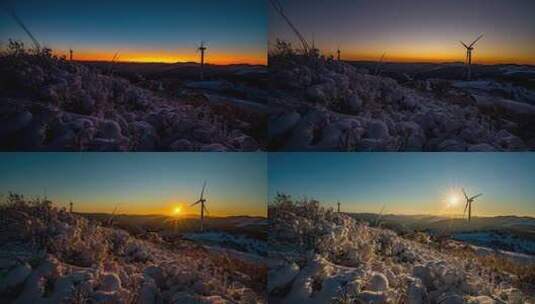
[268, 0, 535, 64]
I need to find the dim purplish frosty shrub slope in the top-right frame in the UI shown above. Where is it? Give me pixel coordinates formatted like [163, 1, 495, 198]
[269, 55, 535, 151]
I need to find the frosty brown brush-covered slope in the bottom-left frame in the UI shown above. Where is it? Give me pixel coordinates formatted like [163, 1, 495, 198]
[0, 197, 266, 304]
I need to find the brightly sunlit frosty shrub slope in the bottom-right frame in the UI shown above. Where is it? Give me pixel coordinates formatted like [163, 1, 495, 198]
[268, 197, 533, 304]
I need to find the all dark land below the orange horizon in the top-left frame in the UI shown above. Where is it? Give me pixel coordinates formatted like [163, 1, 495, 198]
[0, 45, 267, 151]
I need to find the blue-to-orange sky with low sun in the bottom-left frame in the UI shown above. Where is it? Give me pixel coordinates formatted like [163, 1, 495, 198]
[0, 153, 267, 216]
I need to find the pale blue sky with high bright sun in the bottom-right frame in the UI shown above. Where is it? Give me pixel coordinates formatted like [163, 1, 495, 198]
[268, 153, 535, 216]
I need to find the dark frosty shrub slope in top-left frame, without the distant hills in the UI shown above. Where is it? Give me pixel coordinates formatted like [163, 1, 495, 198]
[0, 48, 265, 151]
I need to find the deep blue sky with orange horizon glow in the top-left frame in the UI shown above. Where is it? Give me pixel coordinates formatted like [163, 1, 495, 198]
[0, 0, 267, 64]
